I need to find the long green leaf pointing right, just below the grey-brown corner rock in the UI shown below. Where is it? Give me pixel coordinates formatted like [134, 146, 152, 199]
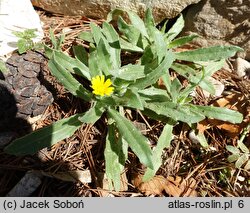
[175, 46, 243, 61]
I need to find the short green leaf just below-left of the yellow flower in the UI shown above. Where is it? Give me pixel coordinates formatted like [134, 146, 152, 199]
[79, 102, 105, 124]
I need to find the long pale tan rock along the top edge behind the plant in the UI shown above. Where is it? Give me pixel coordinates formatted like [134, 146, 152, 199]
[31, 0, 200, 23]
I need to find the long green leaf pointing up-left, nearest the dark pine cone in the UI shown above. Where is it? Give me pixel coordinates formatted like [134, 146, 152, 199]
[48, 58, 92, 101]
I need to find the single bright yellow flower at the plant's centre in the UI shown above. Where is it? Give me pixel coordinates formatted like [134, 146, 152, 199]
[91, 75, 114, 96]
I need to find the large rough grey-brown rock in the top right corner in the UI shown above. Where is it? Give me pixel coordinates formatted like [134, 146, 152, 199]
[183, 0, 250, 60]
